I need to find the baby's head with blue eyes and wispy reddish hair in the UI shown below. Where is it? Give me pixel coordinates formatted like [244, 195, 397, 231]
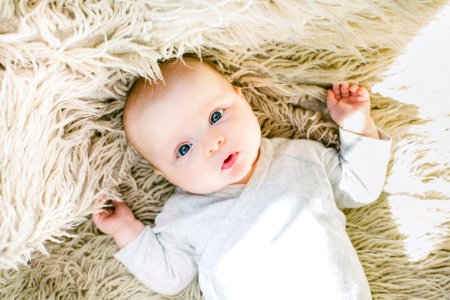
[124, 58, 261, 194]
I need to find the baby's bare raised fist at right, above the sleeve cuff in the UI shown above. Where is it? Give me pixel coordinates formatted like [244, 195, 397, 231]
[327, 83, 379, 138]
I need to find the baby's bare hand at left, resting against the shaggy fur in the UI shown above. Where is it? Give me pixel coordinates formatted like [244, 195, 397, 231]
[92, 197, 144, 248]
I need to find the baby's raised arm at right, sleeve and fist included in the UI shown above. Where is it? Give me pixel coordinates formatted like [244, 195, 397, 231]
[323, 84, 391, 208]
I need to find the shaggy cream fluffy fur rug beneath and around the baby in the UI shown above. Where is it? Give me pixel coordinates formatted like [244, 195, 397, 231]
[0, 0, 450, 299]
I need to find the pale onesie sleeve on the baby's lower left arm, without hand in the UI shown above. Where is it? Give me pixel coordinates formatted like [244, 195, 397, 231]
[115, 226, 197, 295]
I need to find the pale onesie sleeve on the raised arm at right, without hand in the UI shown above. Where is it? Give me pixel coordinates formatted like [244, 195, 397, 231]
[323, 128, 392, 208]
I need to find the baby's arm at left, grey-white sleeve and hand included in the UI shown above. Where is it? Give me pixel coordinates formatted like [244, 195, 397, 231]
[92, 198, 197, 295]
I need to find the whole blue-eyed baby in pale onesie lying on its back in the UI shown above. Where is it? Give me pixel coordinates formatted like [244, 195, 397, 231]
[93, 58, 391, 300]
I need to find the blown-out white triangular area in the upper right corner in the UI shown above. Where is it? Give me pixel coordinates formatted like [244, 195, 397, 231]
[372, 2, 450, 115]
